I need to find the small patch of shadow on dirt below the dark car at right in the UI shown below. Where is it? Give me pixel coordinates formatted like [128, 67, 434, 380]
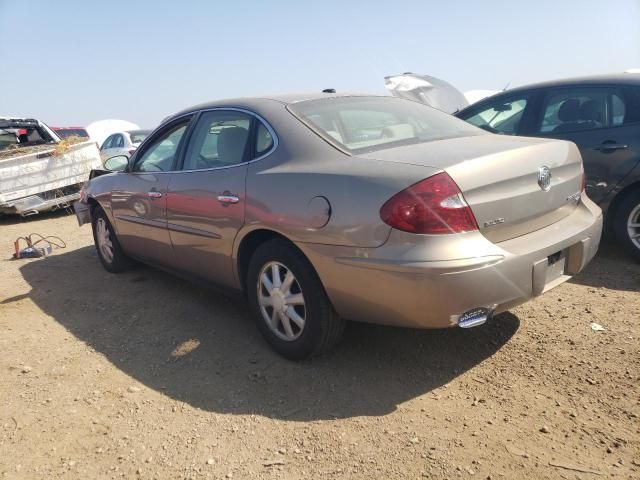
[569, 235, 640, 292]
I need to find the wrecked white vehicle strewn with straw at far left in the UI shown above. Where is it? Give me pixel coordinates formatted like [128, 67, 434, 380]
[0, 118, 102, 216]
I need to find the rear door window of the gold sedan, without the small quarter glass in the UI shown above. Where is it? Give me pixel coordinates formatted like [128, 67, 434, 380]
[183, 110, 252, 170]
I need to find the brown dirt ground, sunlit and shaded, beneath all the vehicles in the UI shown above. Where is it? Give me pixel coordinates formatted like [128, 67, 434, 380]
[0, 214, 640, 479]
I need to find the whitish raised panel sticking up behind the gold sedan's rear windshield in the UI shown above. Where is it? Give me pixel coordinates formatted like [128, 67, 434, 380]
[384, 73, 469, 113]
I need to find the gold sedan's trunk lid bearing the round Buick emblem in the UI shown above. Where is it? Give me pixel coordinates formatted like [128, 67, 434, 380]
[362, 134, 582, 242]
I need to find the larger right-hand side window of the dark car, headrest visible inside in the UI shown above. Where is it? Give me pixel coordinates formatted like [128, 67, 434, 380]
[538, 87, 626, 133]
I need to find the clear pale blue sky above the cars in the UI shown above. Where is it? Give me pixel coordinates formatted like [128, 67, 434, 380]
[0, 0, 640, 128]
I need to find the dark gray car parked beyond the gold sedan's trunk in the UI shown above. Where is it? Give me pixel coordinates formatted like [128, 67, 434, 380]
[455, 73, 640, 260]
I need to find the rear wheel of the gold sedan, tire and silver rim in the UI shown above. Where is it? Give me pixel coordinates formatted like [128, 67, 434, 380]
[246, 239, 344, 360]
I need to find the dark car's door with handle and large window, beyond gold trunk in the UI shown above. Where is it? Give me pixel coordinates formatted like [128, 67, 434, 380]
[533, 85, 640, 203]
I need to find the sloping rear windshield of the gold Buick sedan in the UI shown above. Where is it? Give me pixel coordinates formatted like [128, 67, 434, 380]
[289, 97, 485, 154]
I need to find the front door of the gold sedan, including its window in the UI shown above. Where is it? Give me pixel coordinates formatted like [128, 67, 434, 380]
[111, 118, 190, 265]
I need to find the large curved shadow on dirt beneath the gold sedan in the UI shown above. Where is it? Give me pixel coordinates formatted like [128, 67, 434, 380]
[18, 247, 519, 421]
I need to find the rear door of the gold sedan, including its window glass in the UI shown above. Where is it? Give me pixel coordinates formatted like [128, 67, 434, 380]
[167, 109, 273, 286]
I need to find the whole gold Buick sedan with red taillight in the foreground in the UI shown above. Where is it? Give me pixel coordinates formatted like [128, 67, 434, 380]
[76, 91, 602, 359]
